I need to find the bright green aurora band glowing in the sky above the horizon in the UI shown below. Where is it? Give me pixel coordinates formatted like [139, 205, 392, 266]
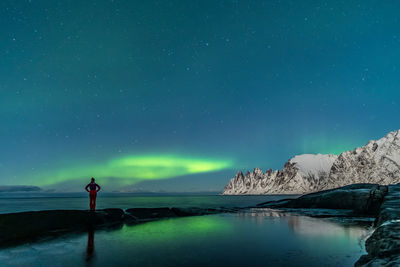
[33, 155, 233, 186]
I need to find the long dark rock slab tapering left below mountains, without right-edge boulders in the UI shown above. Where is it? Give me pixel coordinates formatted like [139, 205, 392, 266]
[258, 184, 388, 216]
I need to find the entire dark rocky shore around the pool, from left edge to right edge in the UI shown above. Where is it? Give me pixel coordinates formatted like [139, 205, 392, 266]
[0, 184, 400, 266]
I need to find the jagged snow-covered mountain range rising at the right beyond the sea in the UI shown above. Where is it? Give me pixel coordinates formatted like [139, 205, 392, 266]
[223, 130, 400, 195]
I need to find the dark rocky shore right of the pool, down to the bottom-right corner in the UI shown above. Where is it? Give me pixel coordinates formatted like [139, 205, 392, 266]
[258, 184, 400, 267]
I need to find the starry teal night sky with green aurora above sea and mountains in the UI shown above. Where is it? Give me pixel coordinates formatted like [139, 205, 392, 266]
[0, 0, 400, 191]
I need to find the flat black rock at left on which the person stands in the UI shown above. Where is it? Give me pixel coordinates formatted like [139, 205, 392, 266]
[0, 208, 236, 247]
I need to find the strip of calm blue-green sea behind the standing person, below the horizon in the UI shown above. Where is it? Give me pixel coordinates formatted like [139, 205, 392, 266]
[0, 193, 290, 213]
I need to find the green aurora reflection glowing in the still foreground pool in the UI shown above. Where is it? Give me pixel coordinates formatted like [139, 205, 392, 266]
[115, 215, 233, 243]
